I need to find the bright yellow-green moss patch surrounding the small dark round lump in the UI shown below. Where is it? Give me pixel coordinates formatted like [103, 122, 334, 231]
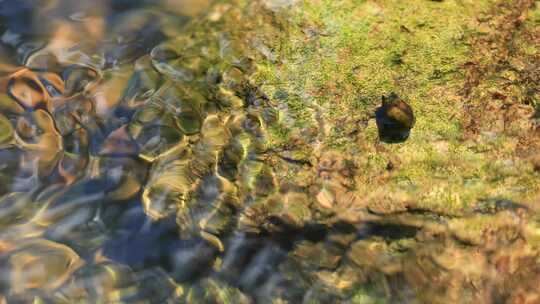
[251, 0, 538, 214]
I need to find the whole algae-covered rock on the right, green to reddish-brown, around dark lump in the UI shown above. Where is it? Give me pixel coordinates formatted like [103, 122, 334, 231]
[243, 0, 540, 303]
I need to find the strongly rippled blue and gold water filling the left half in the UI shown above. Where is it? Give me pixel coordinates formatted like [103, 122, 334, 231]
[0, 0, 320, 303]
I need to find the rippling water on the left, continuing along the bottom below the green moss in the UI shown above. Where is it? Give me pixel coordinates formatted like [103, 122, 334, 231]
[0, 0, 539, 303]
